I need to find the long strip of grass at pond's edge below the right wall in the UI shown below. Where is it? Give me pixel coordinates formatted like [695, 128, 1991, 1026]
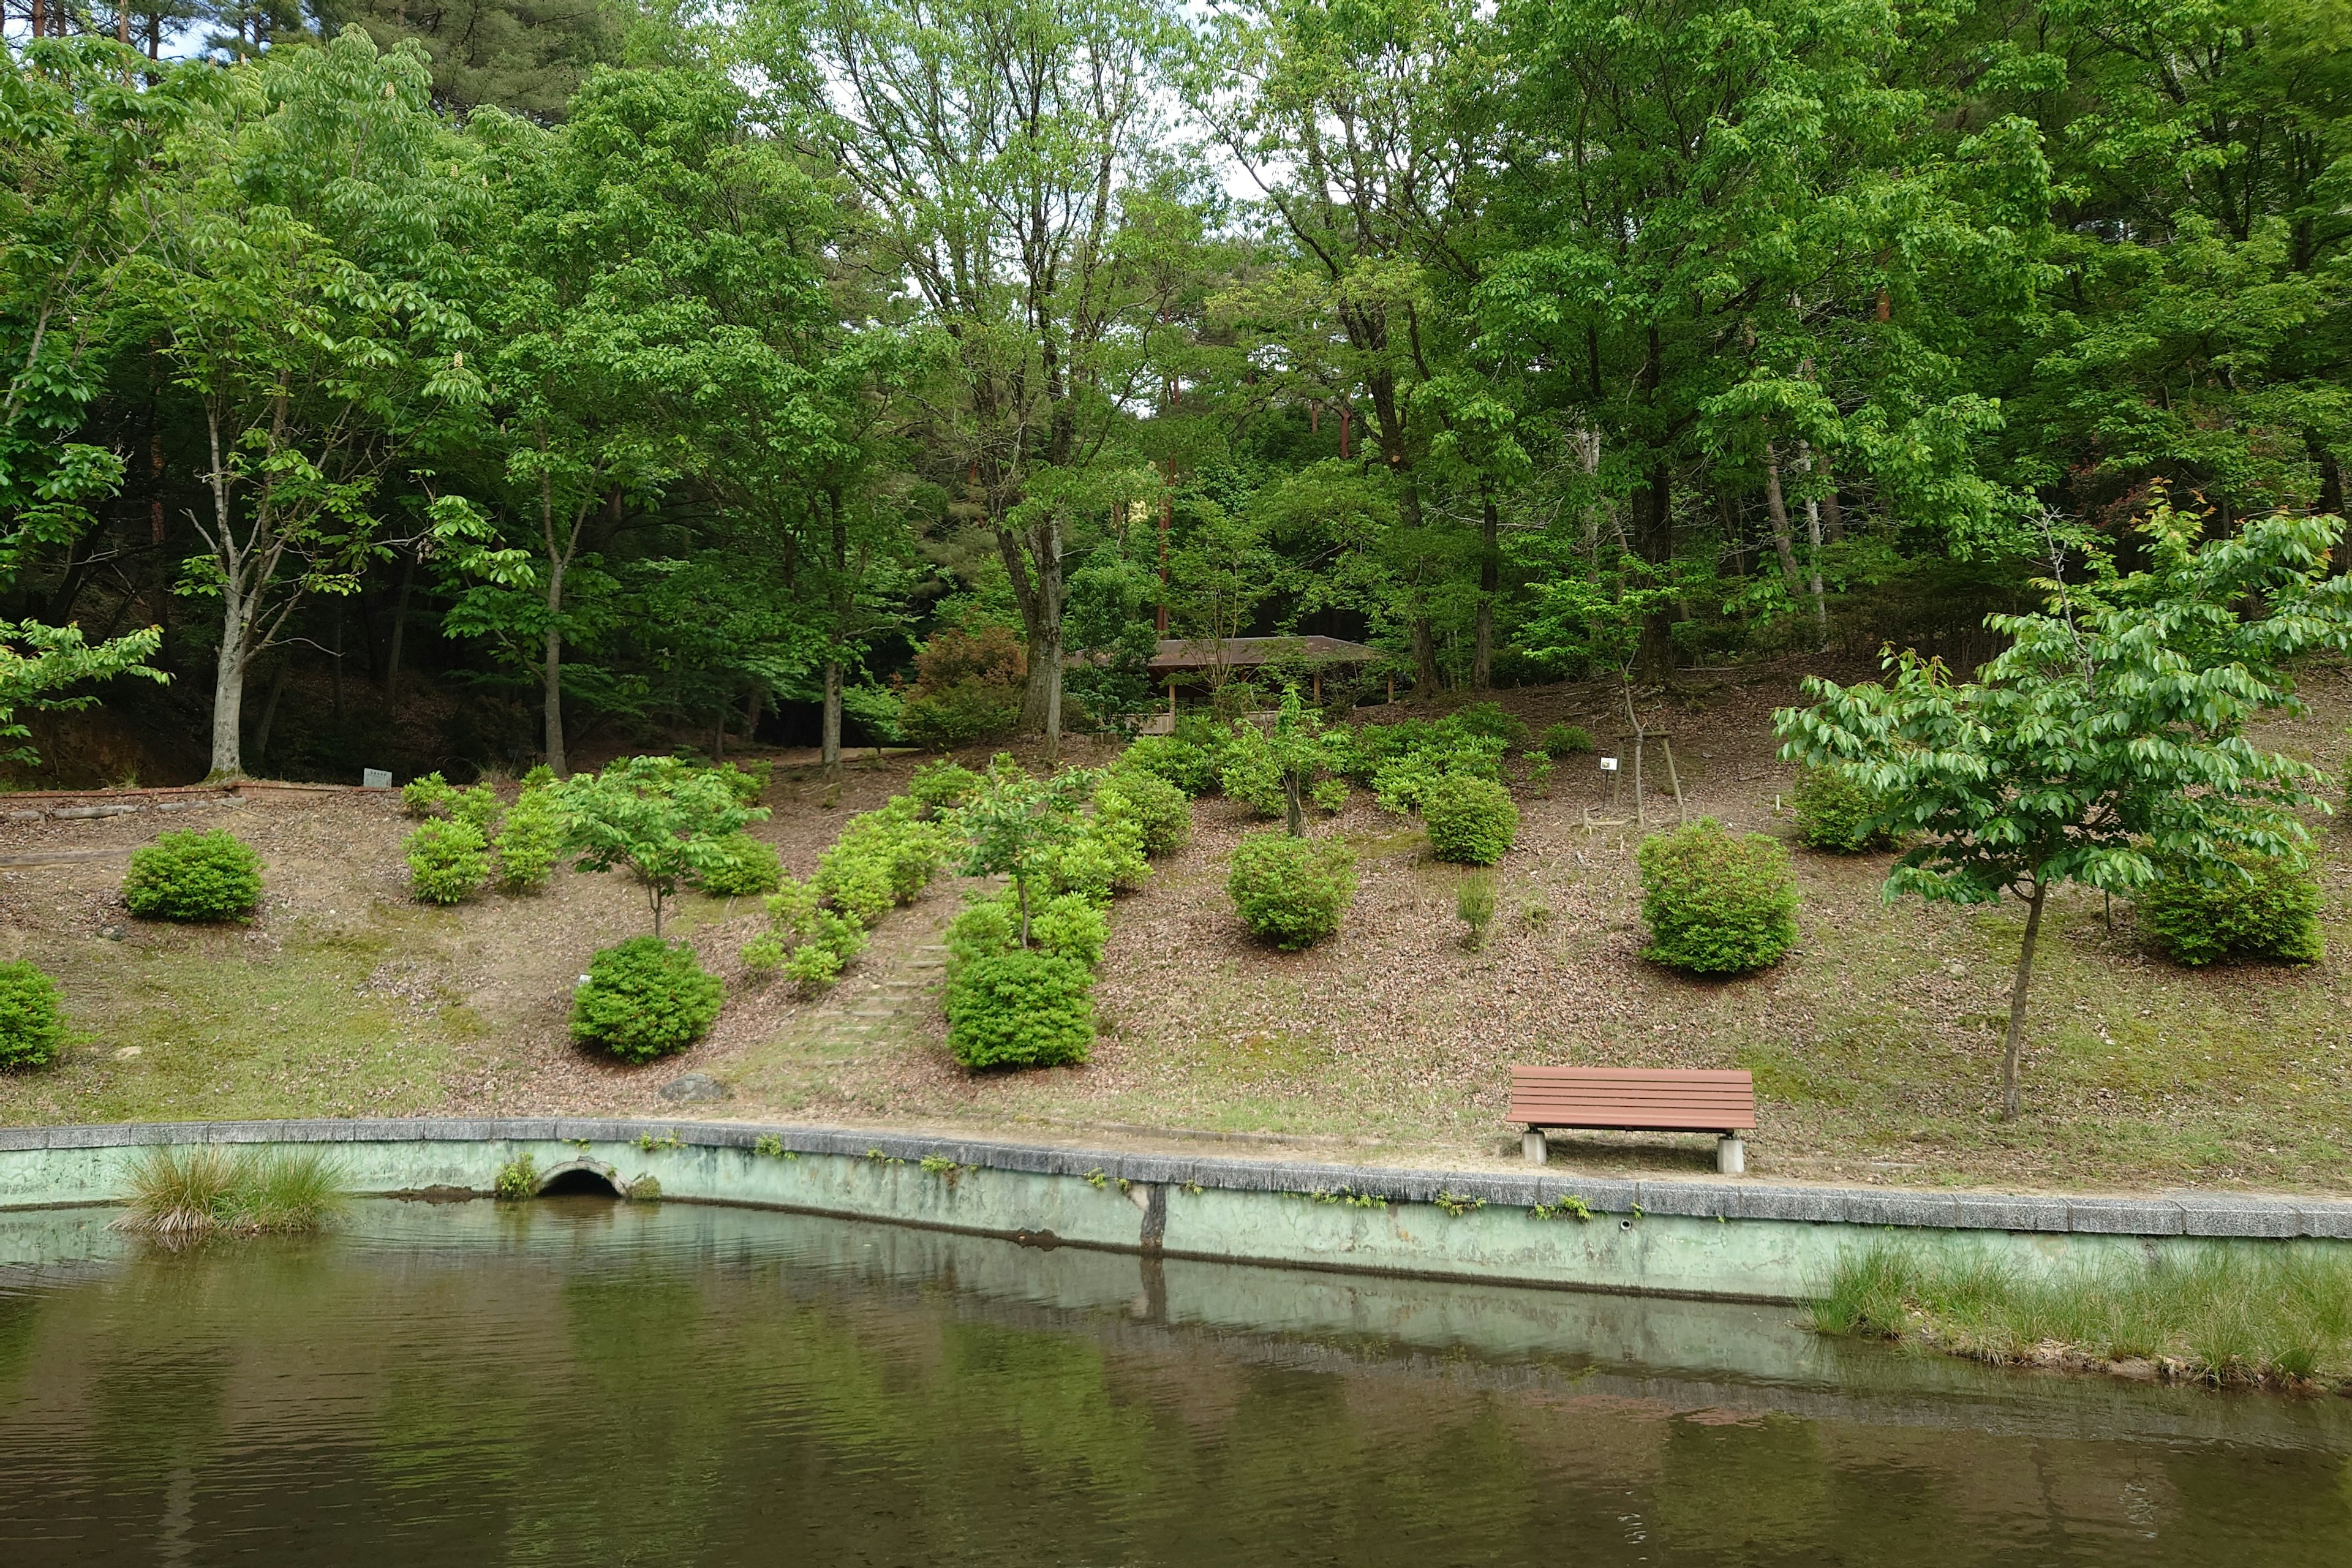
[1814, 1243, 2352, 1387]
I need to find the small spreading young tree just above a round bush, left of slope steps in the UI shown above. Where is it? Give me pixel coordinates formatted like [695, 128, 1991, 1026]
[548, 757, 767, 936]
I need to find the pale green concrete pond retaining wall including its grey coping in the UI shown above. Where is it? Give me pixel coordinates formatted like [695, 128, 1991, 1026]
[0, 1119, 2352, 1302]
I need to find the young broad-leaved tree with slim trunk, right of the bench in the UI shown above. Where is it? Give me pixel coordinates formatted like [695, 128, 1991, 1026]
[1776, 496, 2352, 1121]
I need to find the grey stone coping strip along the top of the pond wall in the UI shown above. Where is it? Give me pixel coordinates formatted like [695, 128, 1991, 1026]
[0, 1117, 2352, 1242]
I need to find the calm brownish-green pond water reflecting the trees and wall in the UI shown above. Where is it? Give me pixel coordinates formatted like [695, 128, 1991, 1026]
[0, 1199, 2352, 1568]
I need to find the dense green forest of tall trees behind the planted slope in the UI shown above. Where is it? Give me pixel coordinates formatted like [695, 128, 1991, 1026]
[0, 0, 2352, 785]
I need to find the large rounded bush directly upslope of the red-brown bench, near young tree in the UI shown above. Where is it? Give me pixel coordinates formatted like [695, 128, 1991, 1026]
[1635, 818, 1797, 976]
